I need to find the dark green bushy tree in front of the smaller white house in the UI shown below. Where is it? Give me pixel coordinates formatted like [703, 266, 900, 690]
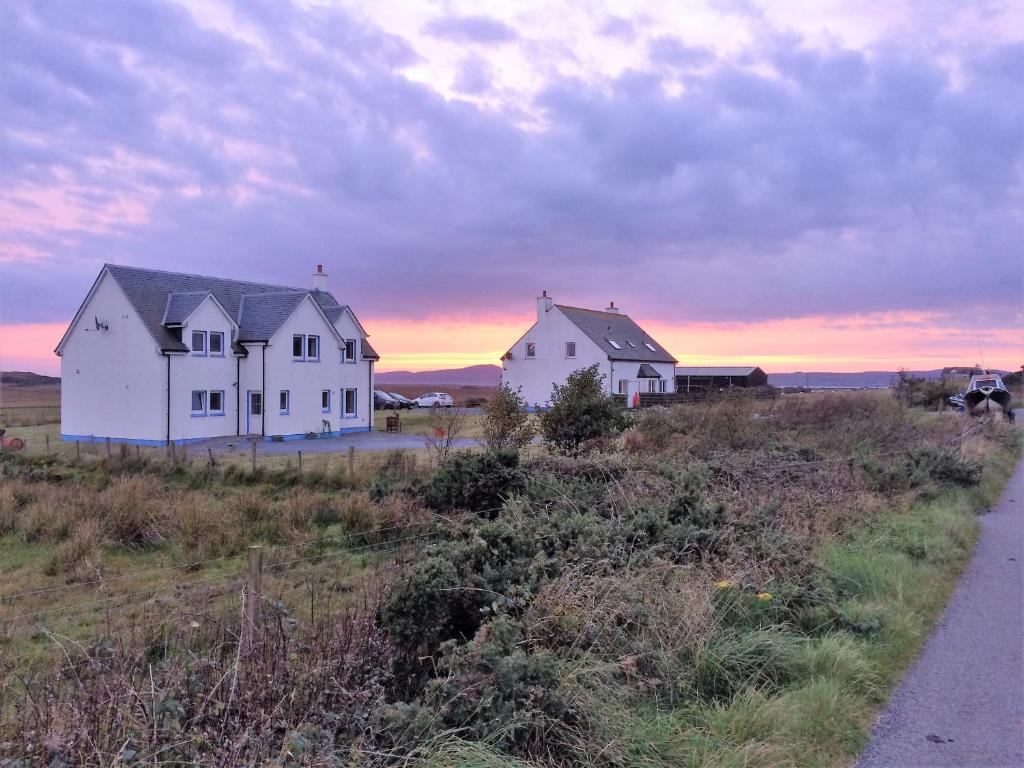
[541, 365, 628, 454]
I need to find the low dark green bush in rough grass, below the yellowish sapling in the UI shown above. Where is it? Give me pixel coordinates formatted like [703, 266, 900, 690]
[421, 450, 523, 517]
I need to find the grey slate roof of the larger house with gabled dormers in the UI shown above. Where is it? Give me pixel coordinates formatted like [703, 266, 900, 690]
[104, 264, 377, 358]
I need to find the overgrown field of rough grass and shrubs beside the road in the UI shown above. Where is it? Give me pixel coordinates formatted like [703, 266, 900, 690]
[0, 393, 1020, 768]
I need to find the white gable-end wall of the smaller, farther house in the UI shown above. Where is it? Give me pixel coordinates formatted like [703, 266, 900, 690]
[502, 305, 606, 408]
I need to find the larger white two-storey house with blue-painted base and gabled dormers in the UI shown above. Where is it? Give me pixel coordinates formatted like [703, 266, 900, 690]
[55, 264, 378, 445]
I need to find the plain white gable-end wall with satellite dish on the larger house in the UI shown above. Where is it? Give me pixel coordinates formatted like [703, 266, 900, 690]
[60, 271, 167, 440]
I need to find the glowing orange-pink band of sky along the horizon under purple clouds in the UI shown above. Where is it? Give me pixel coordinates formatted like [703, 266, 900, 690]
[0, 312, 1024, 374]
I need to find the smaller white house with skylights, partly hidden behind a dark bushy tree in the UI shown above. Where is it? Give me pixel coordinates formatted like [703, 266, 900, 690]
[502, 291, 676, 408]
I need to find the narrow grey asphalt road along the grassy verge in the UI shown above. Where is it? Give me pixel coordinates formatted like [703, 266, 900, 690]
[857, 462, 1024, 768]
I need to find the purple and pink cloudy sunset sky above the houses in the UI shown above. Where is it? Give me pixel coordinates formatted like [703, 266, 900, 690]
[0, 0, 1024, 373]
